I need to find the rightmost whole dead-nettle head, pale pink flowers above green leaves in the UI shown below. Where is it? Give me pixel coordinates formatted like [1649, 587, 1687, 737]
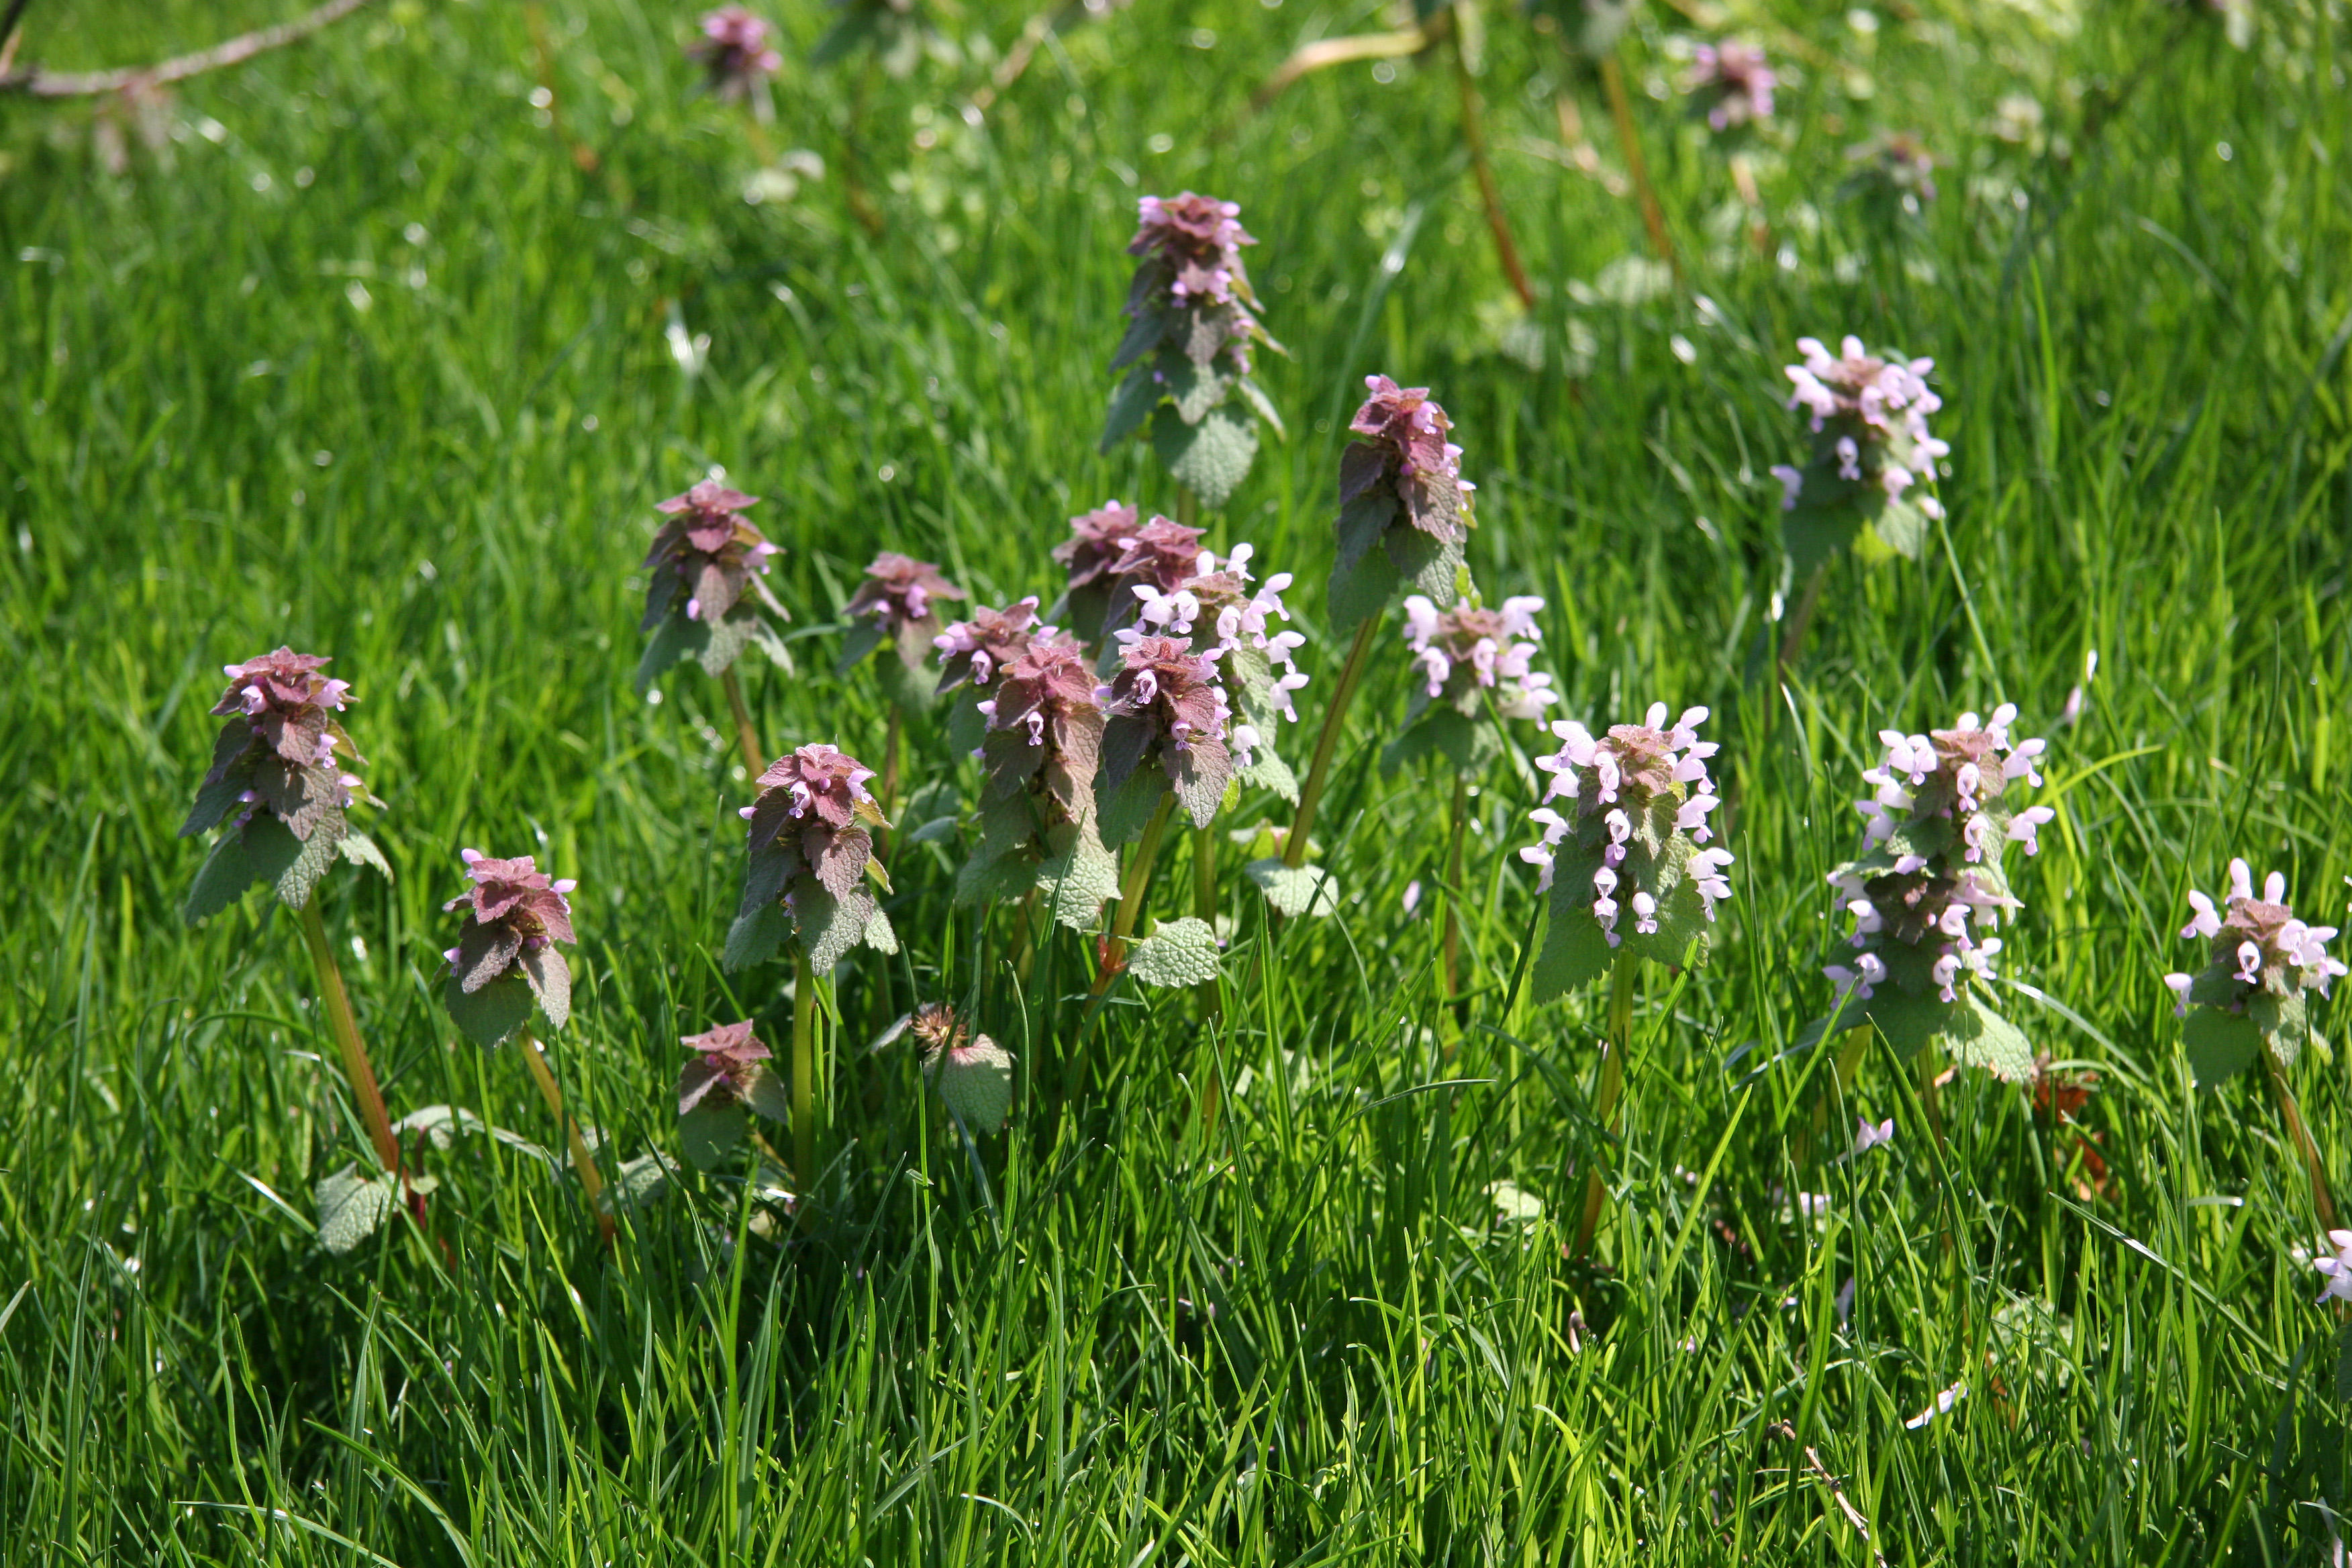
[2164, 861, 2345, 1084]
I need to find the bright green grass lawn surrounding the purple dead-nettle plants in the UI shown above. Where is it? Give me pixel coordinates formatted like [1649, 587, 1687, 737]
[0, 0, 2352, 1565]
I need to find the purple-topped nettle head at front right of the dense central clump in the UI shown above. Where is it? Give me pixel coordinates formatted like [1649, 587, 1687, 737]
[1093, 630, 1235, 844]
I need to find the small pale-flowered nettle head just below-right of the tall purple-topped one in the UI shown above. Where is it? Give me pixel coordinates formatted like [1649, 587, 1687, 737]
[1381, 593, 1559, 773]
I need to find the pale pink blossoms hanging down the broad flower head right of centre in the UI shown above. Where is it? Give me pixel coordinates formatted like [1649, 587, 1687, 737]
[1520, 703, 1731, 947]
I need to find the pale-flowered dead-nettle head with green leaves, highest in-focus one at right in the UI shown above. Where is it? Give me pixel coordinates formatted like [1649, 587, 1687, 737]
[1771, 336, 1950, 579]
